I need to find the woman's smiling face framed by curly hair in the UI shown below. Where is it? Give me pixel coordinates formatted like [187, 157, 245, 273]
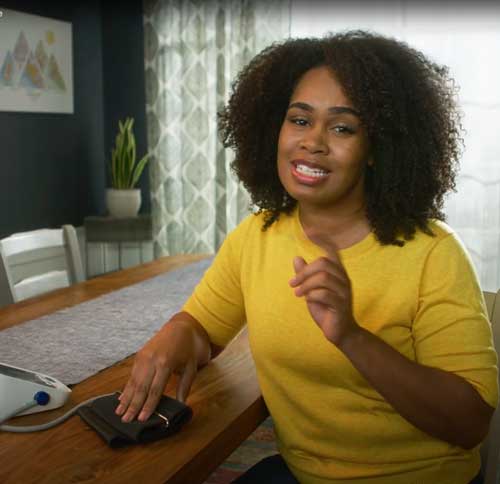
[278, 66, 371, 212]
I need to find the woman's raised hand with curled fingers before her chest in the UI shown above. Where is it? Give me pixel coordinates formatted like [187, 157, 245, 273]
[290, 253, 359, 346]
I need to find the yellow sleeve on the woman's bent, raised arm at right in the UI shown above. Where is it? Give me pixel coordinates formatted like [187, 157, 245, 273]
[413, 233, 498, 407]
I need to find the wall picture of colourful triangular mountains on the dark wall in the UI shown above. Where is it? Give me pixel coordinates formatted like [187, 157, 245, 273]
[0, 7, 74, 114]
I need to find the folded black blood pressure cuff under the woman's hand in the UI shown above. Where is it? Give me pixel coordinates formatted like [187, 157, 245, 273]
[78, 393, 193, 448]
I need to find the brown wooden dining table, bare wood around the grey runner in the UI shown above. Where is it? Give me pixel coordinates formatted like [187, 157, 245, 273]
[0, 255, 268, 484]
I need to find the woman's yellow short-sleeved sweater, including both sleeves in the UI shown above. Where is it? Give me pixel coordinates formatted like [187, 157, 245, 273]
[184, 210, 498, 484]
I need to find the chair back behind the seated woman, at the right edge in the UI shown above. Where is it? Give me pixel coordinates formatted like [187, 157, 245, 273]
[481, 290, 500, 484]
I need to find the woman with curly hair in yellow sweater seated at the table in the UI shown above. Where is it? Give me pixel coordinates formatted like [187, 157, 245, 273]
[117, 31, 498, 484]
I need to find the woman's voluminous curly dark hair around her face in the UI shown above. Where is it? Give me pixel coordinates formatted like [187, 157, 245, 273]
[218, 30, 463, 245]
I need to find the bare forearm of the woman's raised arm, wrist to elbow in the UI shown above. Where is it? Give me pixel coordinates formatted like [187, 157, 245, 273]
[337, 328, 494, 449]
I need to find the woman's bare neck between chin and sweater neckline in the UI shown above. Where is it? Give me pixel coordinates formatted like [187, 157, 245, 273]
[298, 204, 371, 252]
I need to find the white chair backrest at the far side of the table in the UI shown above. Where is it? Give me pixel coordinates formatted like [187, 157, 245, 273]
[0, 225, 85, 306]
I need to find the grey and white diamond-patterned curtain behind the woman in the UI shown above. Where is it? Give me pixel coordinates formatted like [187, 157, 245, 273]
[144, 0, 289, 257]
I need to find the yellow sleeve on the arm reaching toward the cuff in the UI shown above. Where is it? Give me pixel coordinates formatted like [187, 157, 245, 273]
[183, 215, 253, 347]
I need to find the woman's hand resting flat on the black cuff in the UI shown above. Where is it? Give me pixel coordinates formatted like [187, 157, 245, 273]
[116, 313, 211, 422]
